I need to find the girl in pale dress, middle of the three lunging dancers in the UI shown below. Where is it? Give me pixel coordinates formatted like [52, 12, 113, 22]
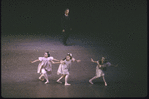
[57, 53, 81, 85]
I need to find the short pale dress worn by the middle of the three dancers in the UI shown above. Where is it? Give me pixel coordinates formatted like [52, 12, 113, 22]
[57, 58, 75, 75]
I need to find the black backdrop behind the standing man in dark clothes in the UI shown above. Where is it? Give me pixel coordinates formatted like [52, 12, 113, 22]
[1, 0, 147, 37]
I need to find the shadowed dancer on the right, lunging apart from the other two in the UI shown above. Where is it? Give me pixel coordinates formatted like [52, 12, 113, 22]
[89, 57, 118, 86]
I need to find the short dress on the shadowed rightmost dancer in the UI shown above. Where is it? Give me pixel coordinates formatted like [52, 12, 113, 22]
[96, 61, 111, 77]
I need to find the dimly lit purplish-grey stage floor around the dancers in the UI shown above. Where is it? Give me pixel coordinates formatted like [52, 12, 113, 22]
[1, 32, 147, 98]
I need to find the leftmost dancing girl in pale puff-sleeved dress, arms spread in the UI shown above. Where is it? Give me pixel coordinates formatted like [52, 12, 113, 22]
[31, 52, 60, 84]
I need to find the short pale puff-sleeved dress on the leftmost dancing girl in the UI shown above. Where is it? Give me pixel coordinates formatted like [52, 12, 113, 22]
[37, 57, 53, 75]
